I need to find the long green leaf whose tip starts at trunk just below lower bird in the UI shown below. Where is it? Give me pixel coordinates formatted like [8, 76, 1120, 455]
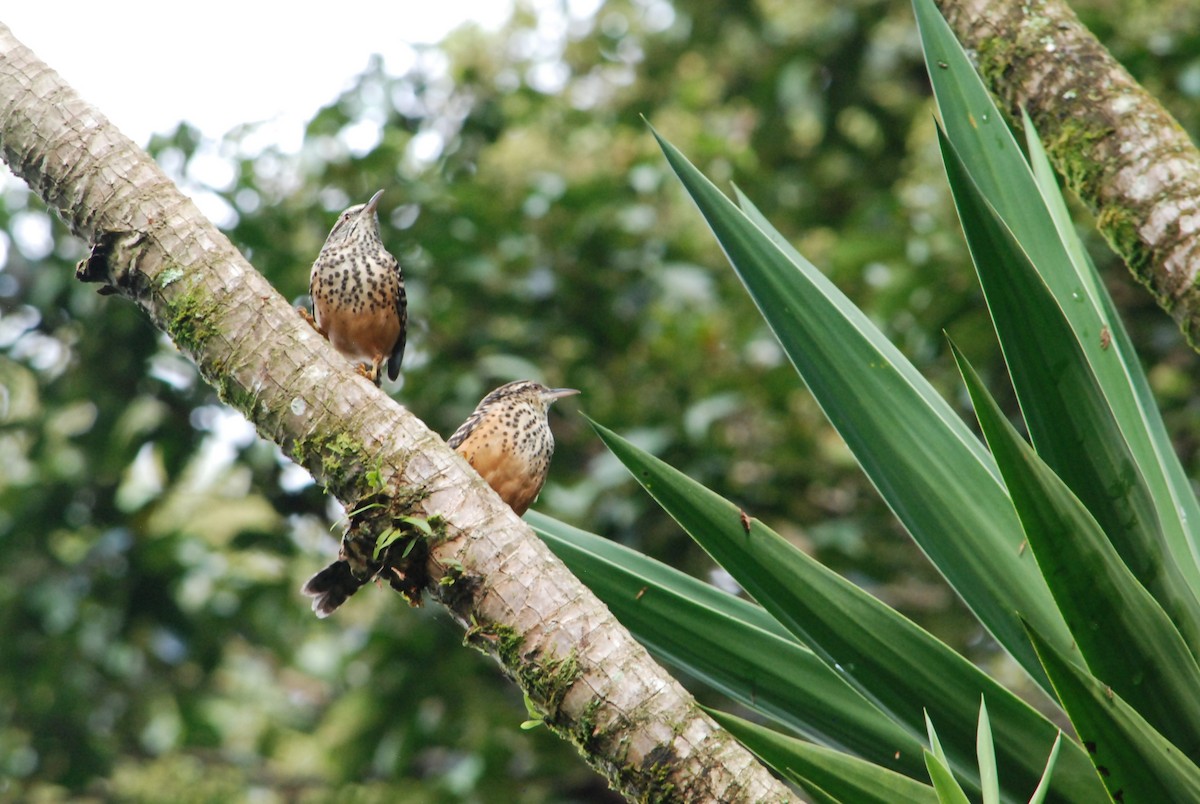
[526, 511, 924, 775]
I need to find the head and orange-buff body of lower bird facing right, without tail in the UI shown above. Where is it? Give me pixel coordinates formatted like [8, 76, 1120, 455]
[446, 379, 578, 516]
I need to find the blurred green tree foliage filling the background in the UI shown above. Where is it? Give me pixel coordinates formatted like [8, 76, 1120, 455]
[0, 0, 1200, 800]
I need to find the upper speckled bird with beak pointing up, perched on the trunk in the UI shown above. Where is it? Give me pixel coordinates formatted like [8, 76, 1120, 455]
[300, 190, 408, 385]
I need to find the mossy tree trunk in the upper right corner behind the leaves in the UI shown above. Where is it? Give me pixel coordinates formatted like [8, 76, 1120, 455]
[935, 0, 1200, 350]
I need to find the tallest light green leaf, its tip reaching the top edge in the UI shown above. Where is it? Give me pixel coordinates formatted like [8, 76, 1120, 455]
[913, 0, 1200, 592]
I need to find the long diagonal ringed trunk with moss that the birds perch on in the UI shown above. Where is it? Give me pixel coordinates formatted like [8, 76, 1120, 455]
[0, 25, 793, 802]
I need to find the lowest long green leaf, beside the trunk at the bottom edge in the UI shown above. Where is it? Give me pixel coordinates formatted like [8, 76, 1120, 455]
[708, 709, 937, 804]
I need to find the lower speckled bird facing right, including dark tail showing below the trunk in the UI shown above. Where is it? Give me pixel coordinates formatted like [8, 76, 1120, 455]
[301, 379, 578, 618]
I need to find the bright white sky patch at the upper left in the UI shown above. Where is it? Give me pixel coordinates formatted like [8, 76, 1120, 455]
[0, 0, 512, 146]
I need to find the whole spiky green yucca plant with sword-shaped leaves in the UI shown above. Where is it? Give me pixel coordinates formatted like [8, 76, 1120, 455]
[529, 0, 1200, 803]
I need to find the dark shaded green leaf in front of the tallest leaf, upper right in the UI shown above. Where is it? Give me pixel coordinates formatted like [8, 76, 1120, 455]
[938, 132, 1200, 646]
